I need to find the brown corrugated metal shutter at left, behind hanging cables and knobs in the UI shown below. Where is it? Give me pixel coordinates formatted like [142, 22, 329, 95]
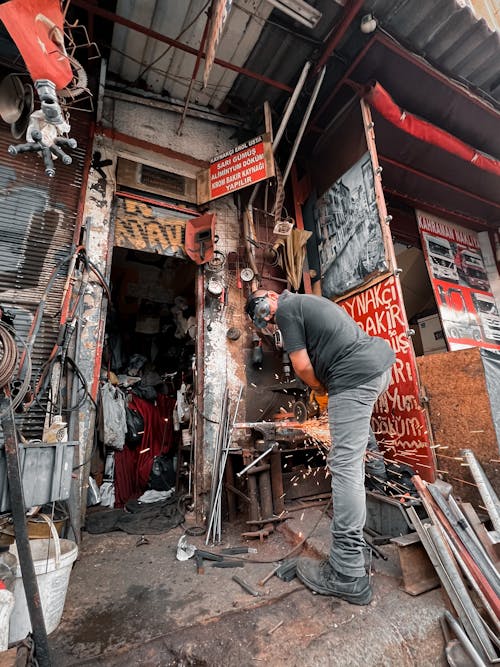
[0, 112, 91, 439]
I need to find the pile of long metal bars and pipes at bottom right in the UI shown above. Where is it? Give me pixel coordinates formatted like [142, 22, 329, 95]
[407, 475, 500, 665]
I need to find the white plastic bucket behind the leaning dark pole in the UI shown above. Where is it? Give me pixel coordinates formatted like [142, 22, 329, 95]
[9, 517, 78, 643]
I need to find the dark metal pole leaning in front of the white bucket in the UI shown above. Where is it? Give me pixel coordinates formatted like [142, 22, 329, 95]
[0, 394, 52, 667]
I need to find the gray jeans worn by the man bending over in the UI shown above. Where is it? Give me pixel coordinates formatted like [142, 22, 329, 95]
[327, 369, 391, 577]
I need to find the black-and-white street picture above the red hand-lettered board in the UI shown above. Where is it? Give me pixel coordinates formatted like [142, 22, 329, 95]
[314, 151, 388, 298]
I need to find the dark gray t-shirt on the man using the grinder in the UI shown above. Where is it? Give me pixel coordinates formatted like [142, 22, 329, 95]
[276, 290, 395, 394]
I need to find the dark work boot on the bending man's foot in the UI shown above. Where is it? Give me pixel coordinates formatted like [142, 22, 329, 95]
[297, 558, 373, 604]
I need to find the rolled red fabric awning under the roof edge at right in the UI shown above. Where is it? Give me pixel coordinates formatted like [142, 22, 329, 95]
[364, 83, 500, 176]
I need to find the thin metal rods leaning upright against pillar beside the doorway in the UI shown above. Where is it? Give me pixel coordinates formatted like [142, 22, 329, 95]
[205, 385, 243, 544]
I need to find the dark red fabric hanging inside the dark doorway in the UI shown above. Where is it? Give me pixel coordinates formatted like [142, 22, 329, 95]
[115, 394, 175, 507]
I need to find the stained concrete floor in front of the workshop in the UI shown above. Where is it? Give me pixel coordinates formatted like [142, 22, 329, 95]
[49, 508, 445, 667]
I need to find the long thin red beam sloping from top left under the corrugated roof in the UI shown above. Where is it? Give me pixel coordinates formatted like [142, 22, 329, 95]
[71, 0, 293, 93]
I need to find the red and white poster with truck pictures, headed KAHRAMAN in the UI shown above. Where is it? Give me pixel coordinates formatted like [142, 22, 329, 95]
[416, 211, 500, 351]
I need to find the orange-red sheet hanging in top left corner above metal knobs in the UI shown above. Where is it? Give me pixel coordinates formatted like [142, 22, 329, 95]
[0, 0, 73, 89]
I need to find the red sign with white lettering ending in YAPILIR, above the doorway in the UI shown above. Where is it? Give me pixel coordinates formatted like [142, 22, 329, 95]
[197, 137, 274, 204]
